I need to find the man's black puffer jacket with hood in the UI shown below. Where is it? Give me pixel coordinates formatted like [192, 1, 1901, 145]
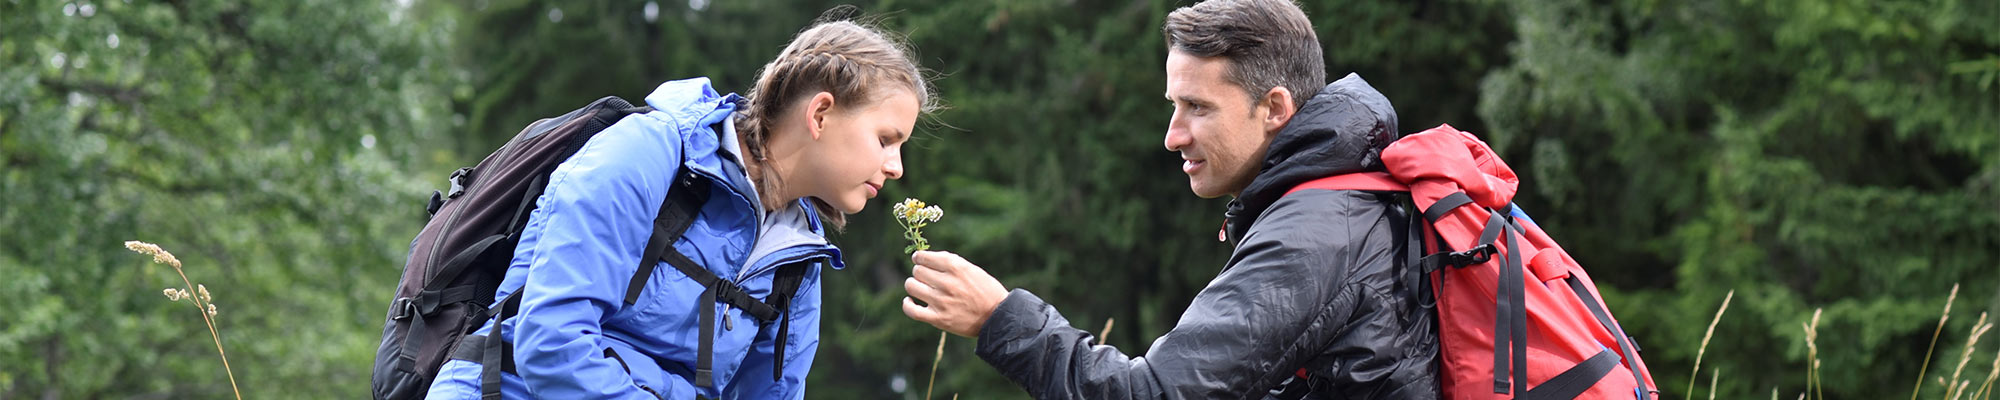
[978, 74, 1438, 400]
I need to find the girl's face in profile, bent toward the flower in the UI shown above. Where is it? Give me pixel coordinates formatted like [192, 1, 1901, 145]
[786, 90, 918, 214]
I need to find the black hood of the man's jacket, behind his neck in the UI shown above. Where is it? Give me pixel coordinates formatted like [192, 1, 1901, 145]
[1228, 74, 1400, 238]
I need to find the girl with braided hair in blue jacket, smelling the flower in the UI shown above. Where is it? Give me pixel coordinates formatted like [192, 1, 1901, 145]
[428, 16, 932, 398]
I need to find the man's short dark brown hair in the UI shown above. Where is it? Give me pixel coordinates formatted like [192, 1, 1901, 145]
[1162, 0, 1326, 110]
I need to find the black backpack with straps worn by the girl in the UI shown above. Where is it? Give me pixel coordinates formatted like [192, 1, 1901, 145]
[372, 96, 804, 400]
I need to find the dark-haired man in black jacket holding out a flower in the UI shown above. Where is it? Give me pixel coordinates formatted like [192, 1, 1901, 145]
[904, 0, 1438, 398]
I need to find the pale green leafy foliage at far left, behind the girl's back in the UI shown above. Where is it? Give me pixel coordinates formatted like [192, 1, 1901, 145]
[0, 0, 450, 398]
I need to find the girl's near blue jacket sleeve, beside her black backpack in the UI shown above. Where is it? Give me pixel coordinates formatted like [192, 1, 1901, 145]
[512, 116, 680, 398]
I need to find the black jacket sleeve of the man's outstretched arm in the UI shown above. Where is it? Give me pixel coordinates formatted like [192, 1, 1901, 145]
[978, 195, 1372, 400]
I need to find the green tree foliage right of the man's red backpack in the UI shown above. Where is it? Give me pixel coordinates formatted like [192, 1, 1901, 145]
[1480, 0, 2000, 398]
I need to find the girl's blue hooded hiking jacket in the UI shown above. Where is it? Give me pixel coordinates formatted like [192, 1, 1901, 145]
[428, 78, 842, 398]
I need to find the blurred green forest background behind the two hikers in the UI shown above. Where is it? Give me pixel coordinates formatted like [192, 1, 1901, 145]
[0, 0, 2000, 400]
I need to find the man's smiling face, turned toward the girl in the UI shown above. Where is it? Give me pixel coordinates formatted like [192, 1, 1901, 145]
[1166, 50, 1276, 198]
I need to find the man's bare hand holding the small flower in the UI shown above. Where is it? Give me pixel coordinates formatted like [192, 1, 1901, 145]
[902, 252, 1006, 338]
